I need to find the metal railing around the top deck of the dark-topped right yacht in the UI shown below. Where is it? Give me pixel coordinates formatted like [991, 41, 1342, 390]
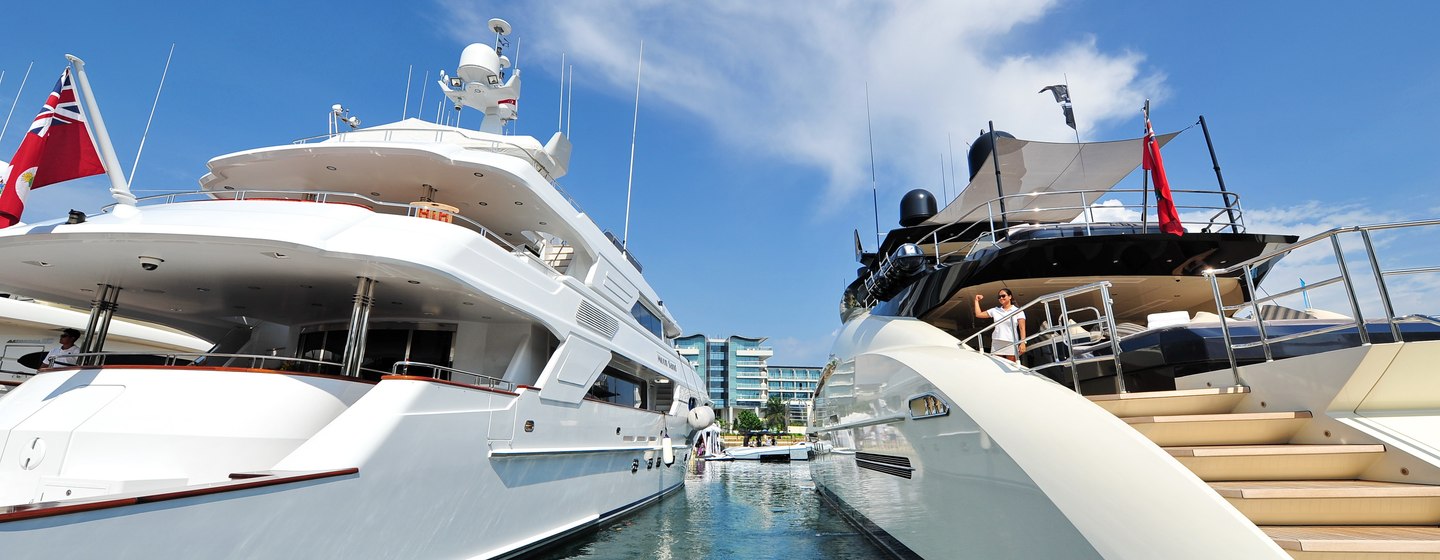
[917, 189, 1246, 263]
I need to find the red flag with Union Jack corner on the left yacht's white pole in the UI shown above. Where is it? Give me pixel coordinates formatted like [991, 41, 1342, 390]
[0, 68, 105, 227]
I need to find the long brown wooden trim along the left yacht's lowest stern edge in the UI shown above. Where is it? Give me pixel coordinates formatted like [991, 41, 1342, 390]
[0, 466, 360, 523]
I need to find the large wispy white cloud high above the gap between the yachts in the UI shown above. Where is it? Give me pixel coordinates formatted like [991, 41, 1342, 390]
[441, 0, 1164, 210]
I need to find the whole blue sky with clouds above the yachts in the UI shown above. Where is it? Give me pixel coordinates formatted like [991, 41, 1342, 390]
[0, 0, 1440, 364]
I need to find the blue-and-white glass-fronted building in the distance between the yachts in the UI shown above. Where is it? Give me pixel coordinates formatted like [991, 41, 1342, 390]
[675, 334, 821, 422]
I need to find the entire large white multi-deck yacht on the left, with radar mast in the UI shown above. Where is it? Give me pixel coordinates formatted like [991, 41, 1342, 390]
[0, 20, 713, 559]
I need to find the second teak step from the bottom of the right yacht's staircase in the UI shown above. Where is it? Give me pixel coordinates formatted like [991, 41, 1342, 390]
[1210, 481, 1440, 525]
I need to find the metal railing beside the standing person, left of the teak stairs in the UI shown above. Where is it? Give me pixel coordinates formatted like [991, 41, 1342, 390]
[960, 281, 1128, 393]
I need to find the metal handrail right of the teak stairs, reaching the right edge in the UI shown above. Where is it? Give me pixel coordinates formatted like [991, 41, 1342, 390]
[1205, 220, 1440, 384]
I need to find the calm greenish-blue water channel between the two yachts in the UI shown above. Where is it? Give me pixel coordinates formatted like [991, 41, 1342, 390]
[541, 461, 883, 560]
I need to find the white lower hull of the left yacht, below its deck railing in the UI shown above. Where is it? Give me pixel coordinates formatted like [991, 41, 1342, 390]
[0, 370, 688, 559]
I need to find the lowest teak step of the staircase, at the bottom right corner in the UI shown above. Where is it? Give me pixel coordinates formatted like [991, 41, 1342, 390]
[1260, 527, 1440, 560]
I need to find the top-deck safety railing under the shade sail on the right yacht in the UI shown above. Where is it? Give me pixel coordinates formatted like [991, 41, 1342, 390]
[926, 189, 1246, 263]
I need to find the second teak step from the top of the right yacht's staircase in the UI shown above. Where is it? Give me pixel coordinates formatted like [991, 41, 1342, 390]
[1123, 410, 1310, 448]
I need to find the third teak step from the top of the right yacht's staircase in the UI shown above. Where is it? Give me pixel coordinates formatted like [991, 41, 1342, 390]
[1165, 443, 1385, 482]
